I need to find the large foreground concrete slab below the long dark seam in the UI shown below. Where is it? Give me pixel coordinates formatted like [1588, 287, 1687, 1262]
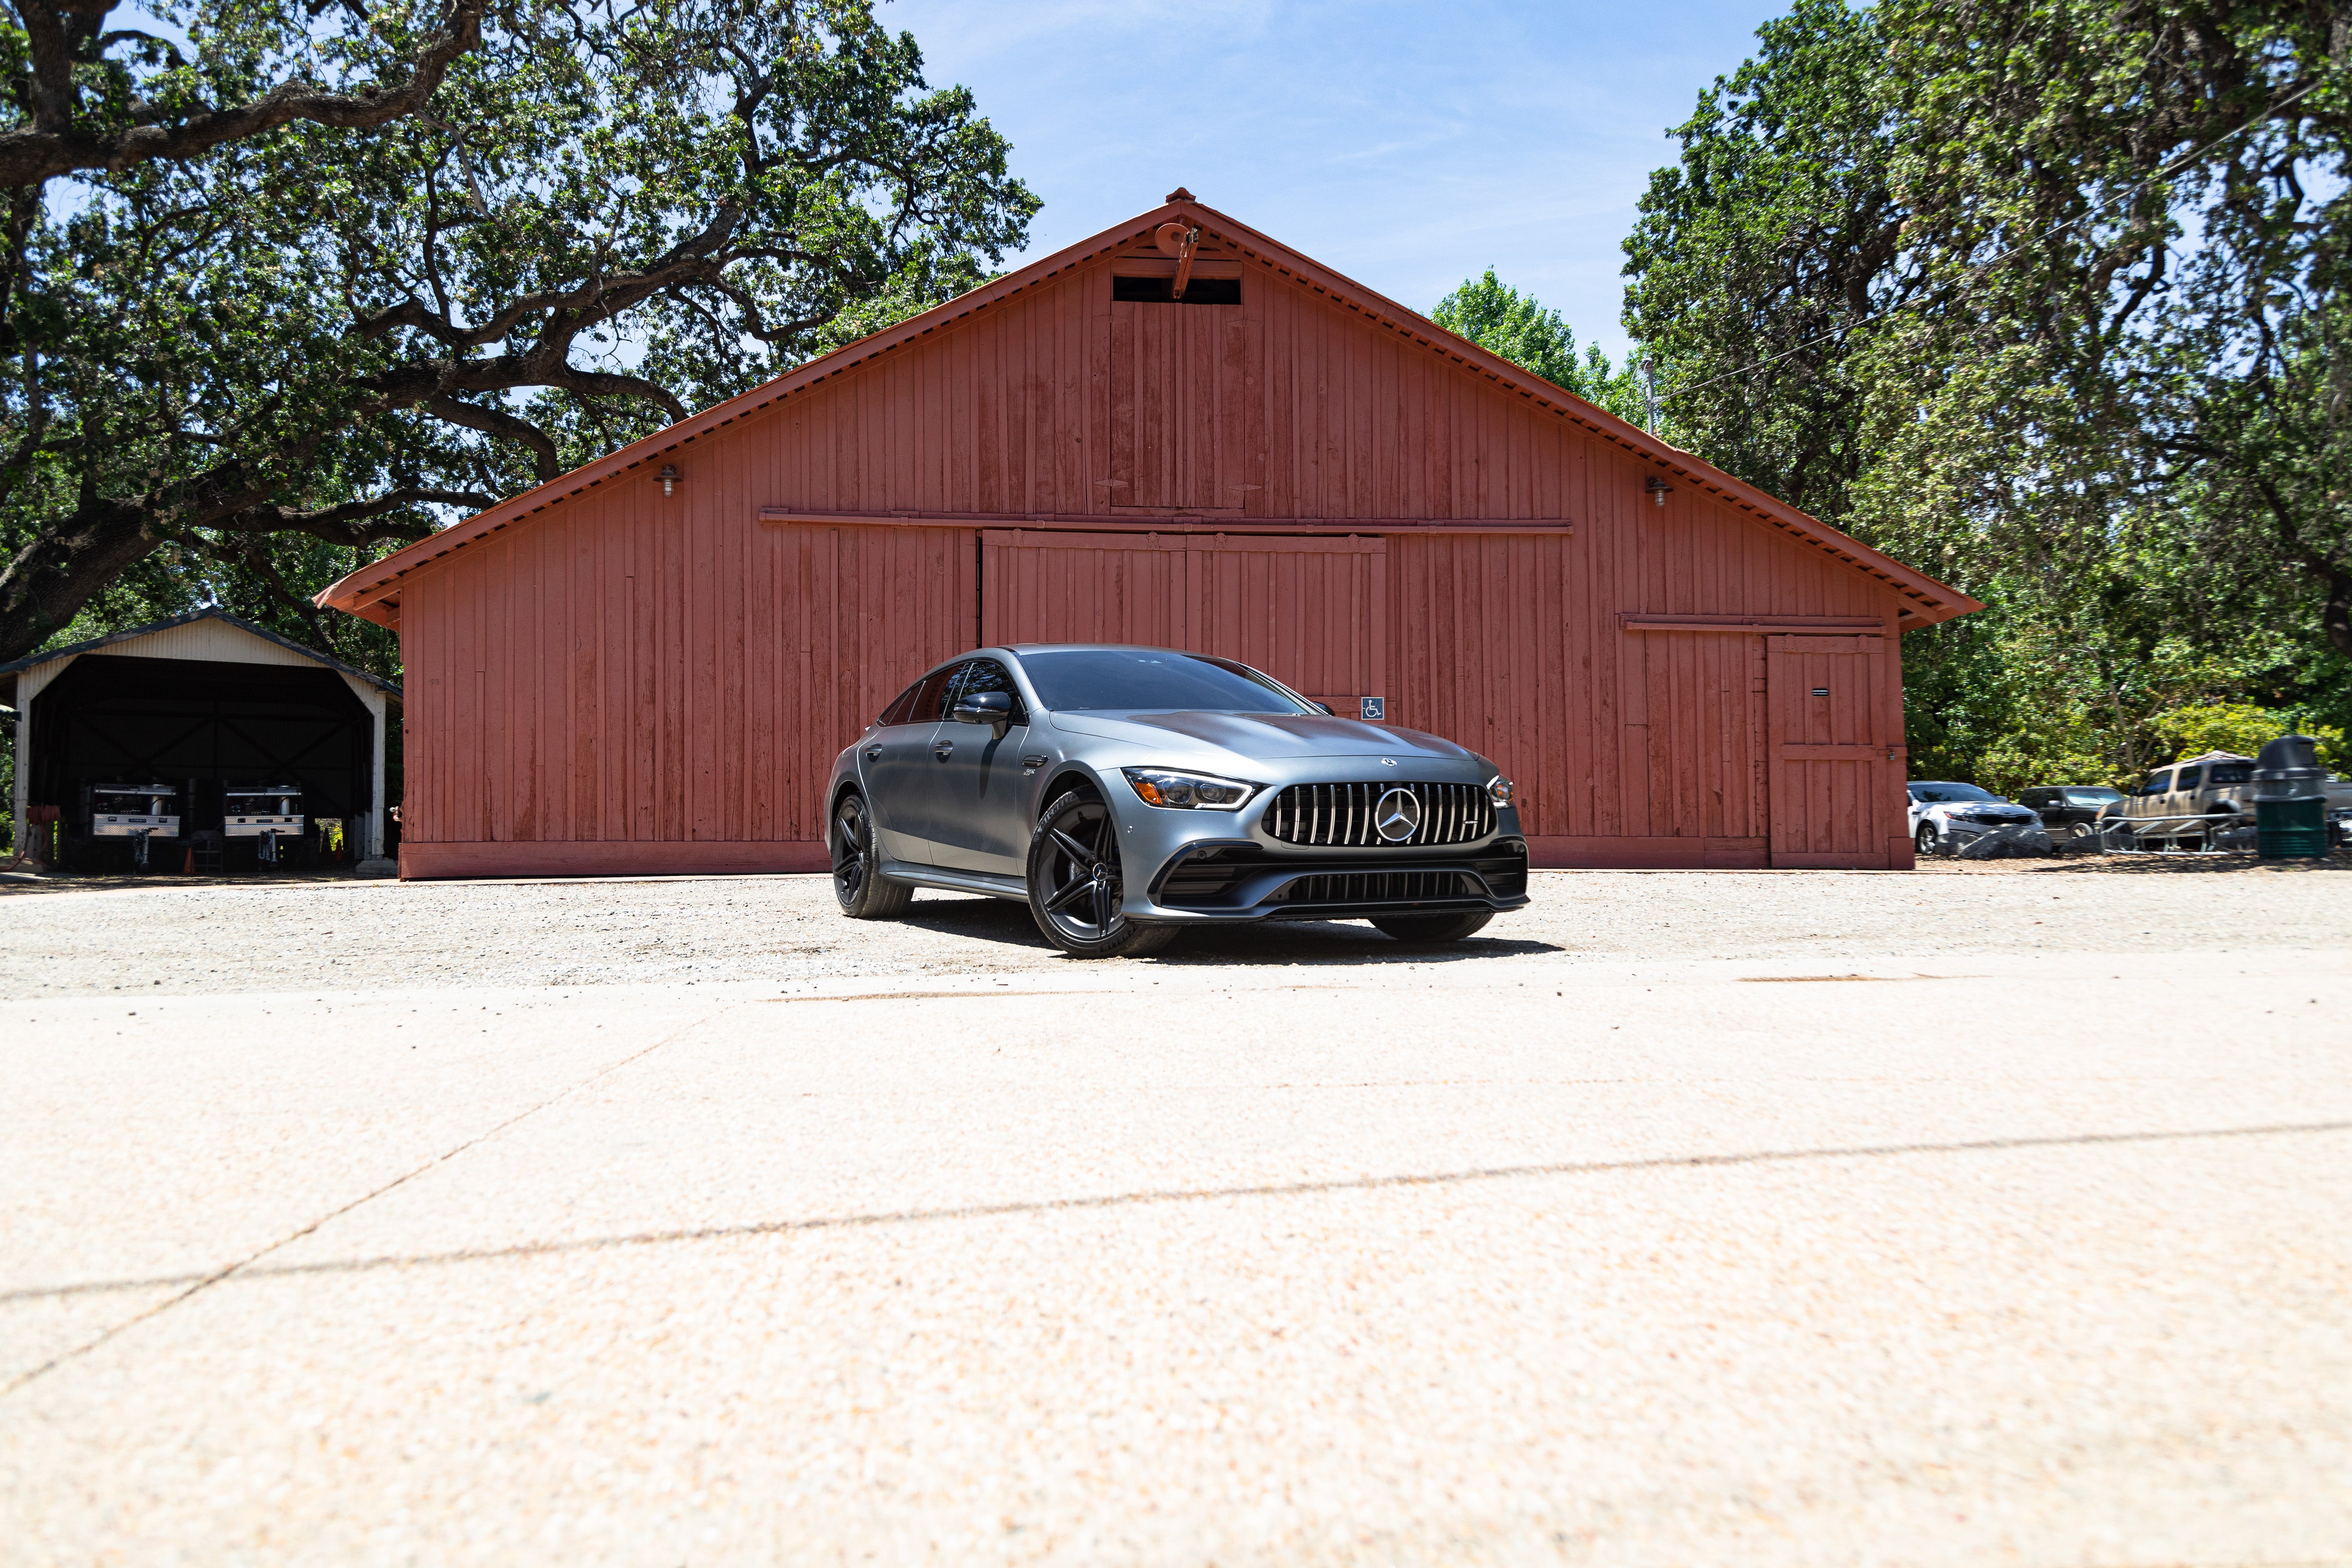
[0, 1136, 2352, 1563]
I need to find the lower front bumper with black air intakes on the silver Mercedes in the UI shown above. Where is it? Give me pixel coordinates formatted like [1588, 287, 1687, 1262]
[1127, 835, 1526, 924]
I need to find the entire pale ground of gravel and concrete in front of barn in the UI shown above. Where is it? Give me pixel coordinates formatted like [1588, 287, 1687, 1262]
[0, 860, 2352, 1568]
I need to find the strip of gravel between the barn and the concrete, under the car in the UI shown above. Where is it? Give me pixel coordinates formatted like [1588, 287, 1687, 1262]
[0, 856, 2352, 999]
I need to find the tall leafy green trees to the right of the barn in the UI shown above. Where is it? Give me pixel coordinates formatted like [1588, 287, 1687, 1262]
[1625, 0, 2352, 790]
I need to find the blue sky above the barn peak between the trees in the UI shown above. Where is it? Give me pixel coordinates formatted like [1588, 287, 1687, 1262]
[877, 0, 1785, 355]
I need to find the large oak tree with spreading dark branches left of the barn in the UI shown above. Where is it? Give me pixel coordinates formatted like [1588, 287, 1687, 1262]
[0, 0, 1037, 668]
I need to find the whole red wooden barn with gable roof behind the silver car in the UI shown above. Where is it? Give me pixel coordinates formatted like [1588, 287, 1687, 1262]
[320, 191, 1980, 877]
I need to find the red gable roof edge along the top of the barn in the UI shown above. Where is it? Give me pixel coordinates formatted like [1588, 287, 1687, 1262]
[318, 191, 1983, 628]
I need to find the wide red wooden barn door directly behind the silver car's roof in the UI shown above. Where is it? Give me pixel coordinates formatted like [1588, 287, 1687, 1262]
[981, 529, 1388, 717]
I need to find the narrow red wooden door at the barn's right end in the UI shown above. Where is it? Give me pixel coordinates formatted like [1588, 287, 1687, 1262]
[1766, 637, 1907, 868]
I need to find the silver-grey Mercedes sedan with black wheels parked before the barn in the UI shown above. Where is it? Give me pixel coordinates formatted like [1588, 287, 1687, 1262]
[826, 644, 1526, 959]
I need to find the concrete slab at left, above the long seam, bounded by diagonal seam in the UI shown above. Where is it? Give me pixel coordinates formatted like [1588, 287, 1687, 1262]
[0, 992, 724, 1293]
